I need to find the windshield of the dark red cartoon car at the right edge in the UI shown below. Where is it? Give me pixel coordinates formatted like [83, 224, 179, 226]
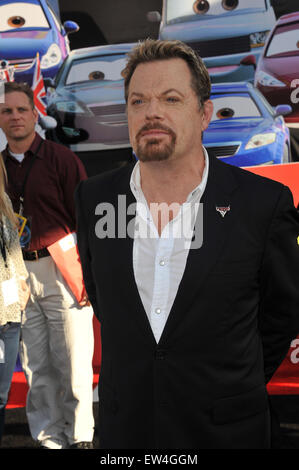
[266, 22, 299, 57]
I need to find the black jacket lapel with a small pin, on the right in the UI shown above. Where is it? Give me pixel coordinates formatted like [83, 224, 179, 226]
[159, 155, 239, 345]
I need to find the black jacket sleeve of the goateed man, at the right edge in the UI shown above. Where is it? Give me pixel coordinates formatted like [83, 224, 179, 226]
[259, 187, 299, 382]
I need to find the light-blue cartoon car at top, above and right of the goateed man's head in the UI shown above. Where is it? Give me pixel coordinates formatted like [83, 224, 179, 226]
[148, 0, 276, 83]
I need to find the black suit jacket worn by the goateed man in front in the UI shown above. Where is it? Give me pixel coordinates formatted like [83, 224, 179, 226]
[76, 155, 299, 449]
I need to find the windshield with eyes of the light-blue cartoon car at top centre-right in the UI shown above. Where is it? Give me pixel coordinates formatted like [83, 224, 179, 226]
[166, 0, 265, 23]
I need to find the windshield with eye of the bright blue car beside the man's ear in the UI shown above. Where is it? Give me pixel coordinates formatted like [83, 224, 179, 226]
[211, 94, 261, 121]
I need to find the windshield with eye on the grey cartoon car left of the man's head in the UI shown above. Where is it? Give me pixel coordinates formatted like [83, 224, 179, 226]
[65, 55, 126, 85]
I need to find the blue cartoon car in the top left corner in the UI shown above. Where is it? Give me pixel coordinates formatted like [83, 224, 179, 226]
[0, 0, 79, 85]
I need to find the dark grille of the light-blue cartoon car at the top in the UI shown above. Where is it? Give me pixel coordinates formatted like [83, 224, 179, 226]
[188, 36, 250, 57]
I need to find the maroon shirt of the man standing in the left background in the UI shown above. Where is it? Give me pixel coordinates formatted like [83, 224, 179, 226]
[3, 134, 87, 251]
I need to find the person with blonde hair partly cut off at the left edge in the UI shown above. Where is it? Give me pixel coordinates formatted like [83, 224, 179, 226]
[0, 154, 29, 444]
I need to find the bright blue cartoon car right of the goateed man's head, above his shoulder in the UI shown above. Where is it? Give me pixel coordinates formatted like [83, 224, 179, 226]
[203, 82, 292, 167]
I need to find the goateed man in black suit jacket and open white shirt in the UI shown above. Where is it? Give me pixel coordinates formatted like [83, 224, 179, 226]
[76, 40, 299, 449]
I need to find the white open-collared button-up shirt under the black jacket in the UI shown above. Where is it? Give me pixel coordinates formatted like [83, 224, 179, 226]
[130, 148, 209, 343]
